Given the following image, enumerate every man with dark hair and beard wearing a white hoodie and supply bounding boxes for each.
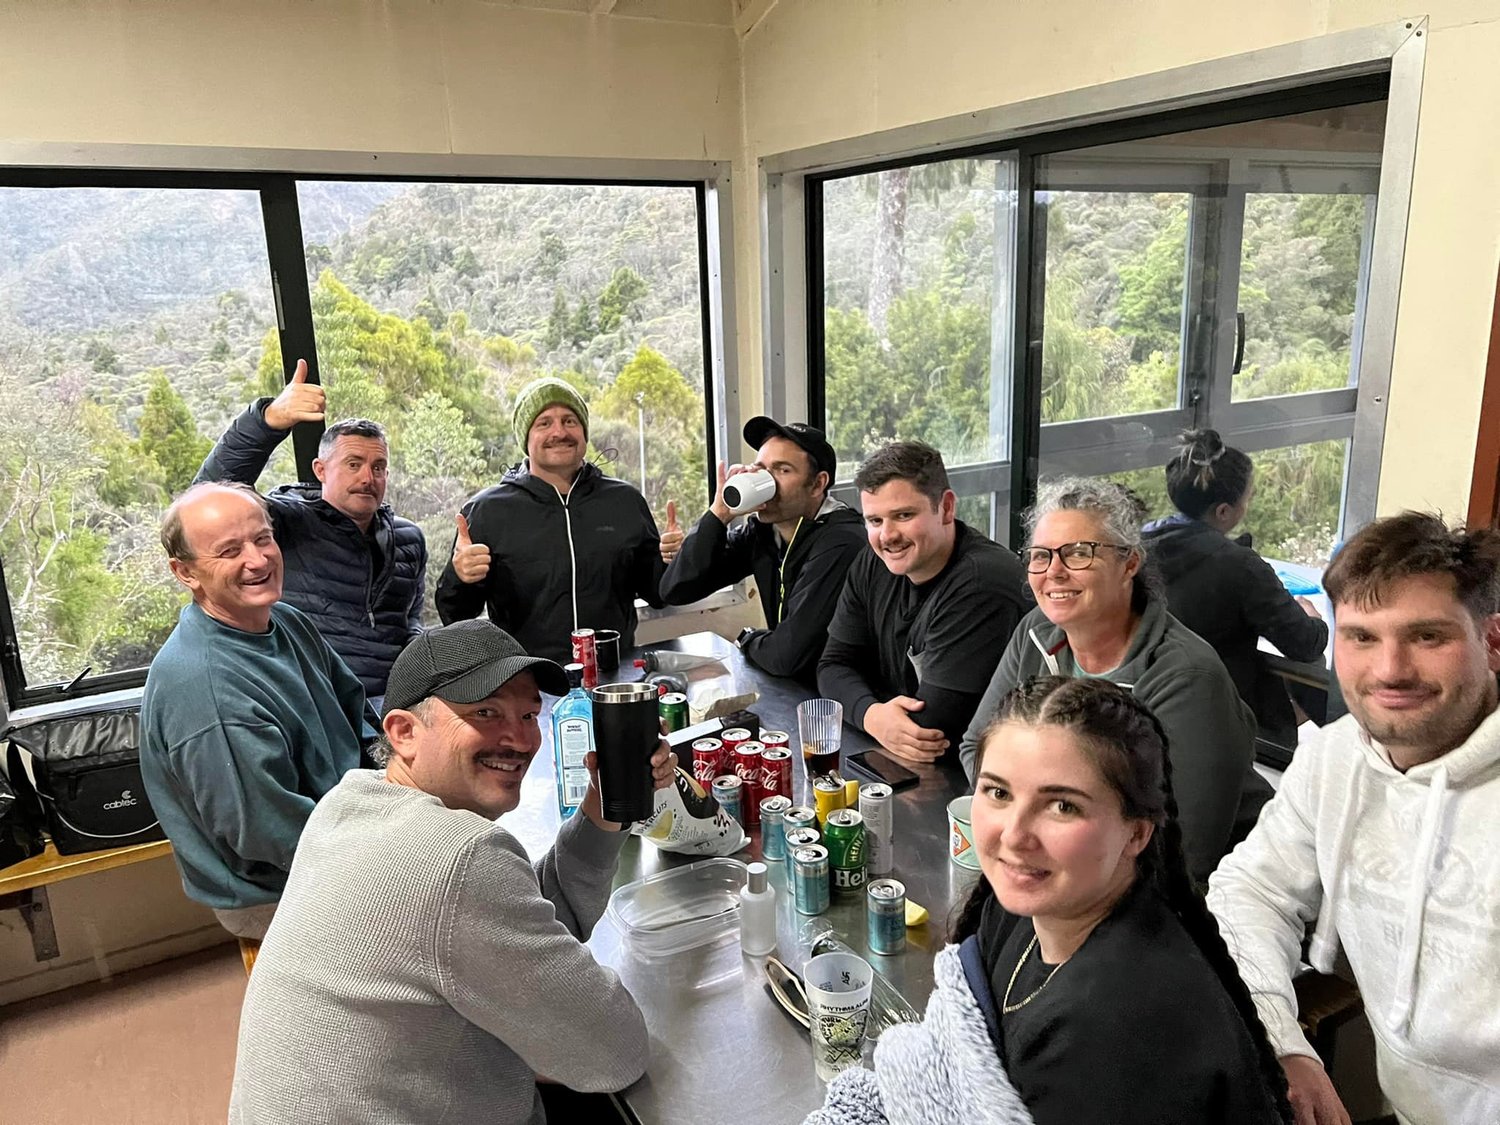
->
[1208,512,1500,1125]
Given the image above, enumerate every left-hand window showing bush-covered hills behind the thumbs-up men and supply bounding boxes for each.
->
[0,173,714,707]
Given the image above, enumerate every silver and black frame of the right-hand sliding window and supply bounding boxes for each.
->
[762,20,1427,552]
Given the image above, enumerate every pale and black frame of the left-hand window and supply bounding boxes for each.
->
[0,156,741,722]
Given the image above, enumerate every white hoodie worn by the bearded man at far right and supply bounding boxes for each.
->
[1208,711,1500,1125]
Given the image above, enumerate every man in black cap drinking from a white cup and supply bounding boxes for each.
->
[662,417,864,684]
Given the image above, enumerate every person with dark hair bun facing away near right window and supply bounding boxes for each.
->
[1143,429,1328,746]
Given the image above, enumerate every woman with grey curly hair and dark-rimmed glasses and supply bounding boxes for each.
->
[960,477,1271,884]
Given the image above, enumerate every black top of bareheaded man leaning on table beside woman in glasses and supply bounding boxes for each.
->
[819,521,1029,726]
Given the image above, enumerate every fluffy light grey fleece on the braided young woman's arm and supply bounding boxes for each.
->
[803,945,1032,1125]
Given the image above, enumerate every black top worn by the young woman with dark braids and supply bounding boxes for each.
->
[980,885,1281,1125]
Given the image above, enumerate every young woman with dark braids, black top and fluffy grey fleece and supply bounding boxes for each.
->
[807,677,1292,1125]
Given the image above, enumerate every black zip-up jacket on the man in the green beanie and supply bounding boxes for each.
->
[435,461,666,662]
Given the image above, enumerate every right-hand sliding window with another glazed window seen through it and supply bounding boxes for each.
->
[806,80,1386,564]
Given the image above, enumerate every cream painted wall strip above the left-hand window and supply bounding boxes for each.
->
[0,0,740,161]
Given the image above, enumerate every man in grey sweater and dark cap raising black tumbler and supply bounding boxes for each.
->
[230,621,672,1125]
